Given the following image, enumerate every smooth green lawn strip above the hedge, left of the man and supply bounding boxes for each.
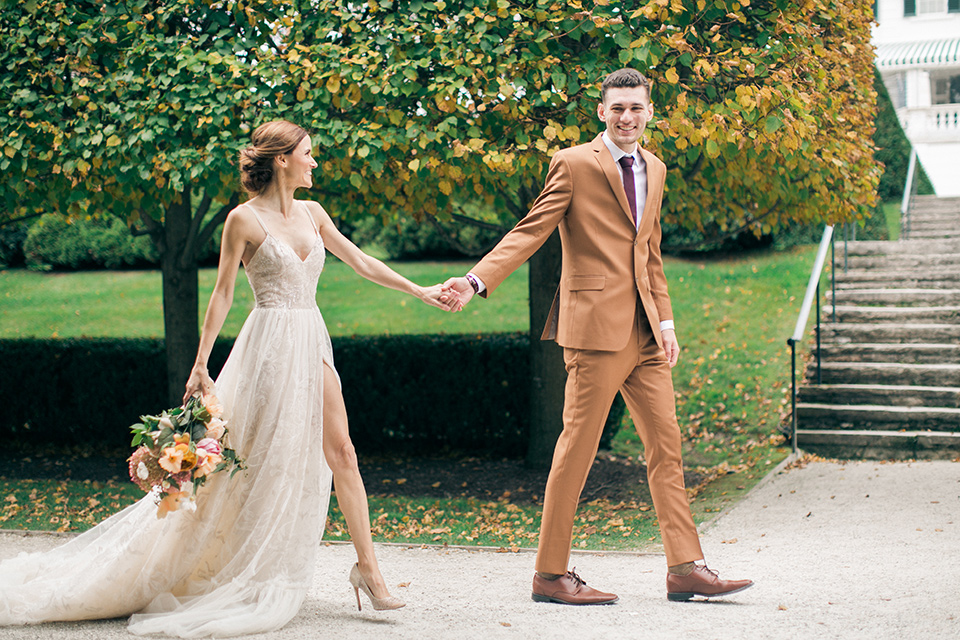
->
[0,260,530,338]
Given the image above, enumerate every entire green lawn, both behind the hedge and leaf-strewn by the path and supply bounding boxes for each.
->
[0,247,816,549]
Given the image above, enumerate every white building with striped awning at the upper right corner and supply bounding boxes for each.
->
[873,0,960,198]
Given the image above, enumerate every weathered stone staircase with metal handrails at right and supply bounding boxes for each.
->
[797,196,960,459]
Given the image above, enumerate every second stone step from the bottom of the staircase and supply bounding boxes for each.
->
[797,403,960,432]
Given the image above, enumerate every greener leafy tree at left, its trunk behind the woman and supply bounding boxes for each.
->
[0,0,286,400]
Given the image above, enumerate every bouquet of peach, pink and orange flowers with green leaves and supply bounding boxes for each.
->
[129,394,244,518]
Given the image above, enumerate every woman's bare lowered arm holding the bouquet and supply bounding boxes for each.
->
[183,209,247,402]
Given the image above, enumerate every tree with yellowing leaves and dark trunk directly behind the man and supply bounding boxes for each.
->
[276,0,879,464]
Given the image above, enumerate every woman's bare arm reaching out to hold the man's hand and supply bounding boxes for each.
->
[308,202,460,311]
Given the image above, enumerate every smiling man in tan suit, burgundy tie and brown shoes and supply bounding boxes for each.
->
[445,69,753,605]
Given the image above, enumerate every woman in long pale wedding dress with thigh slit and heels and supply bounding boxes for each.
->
[0,121,459,638]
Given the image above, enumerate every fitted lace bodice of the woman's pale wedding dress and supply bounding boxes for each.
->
[246,221,326,309]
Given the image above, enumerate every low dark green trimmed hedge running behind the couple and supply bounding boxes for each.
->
[0,333,624,458]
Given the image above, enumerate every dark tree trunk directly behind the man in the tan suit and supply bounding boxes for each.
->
[526,231,567,469]
